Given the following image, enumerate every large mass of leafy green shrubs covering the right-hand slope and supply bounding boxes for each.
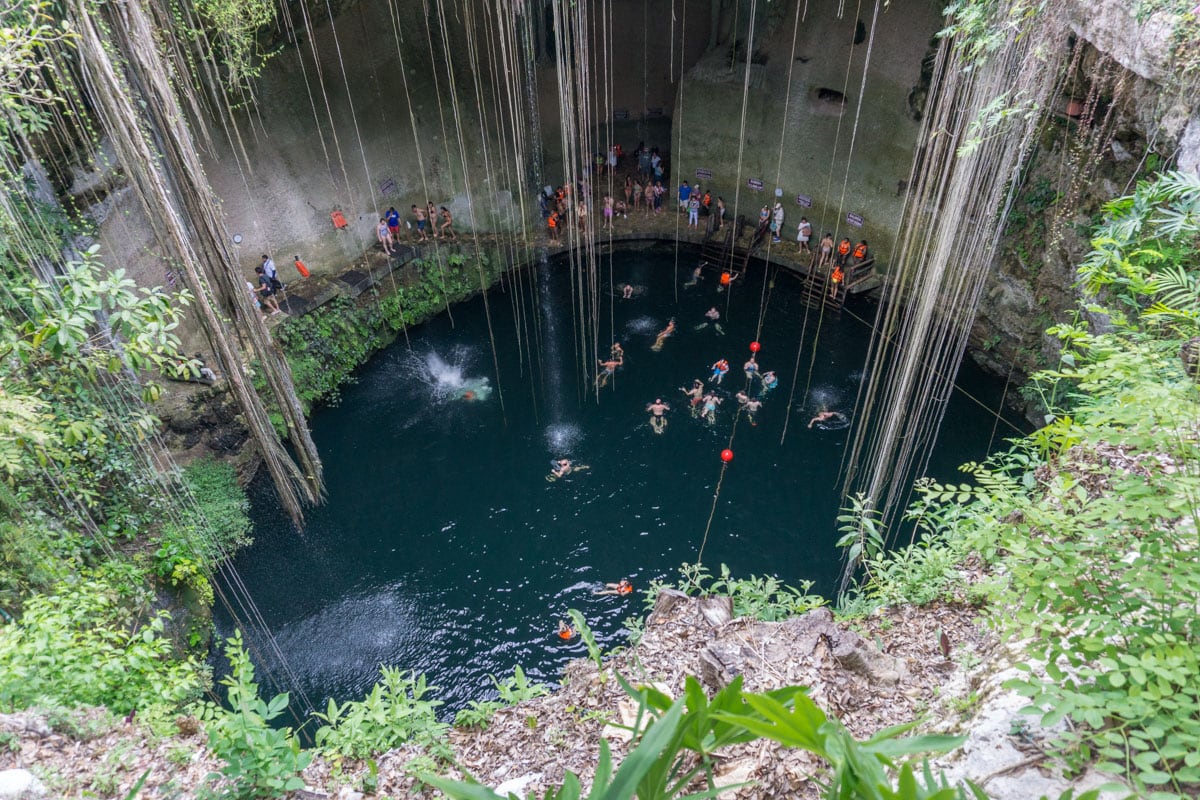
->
[840,174,1200,799]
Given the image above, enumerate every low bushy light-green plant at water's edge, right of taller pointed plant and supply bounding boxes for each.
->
[313,667,449,758]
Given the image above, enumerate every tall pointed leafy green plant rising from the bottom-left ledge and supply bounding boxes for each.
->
[203,631,312,799]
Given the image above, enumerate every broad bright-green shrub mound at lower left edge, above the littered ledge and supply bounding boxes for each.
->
[0,570,205,715]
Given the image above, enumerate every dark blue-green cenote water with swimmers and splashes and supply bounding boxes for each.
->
[218,251,1010,709]
